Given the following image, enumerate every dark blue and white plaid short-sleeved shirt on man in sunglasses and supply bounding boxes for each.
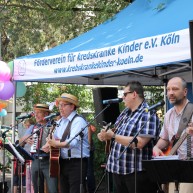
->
[106,101,159,175]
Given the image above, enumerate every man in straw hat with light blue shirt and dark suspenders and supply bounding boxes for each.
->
[44,93,89,193]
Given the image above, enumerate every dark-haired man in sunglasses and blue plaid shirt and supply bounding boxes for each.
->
[98,81,159,193]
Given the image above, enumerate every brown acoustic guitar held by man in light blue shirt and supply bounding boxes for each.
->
[50,126,60,177]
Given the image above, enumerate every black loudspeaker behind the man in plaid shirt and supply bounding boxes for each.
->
[93,87,120,125]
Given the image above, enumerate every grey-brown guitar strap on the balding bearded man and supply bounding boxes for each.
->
[175,103,193,139]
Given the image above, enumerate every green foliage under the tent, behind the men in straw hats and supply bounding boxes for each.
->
[17,82,94,113]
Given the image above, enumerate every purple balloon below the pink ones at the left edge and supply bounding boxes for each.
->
[0,81,15,100]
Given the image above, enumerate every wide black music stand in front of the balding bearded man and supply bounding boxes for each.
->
[142,160,193,192]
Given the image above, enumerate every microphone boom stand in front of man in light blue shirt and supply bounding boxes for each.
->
[67,104,110,193]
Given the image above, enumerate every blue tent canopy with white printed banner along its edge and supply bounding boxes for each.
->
[14,0,193,85]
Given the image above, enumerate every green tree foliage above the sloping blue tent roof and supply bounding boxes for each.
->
[0,0,129,61]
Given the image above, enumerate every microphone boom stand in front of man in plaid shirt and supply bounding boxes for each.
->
[117,110,156,193]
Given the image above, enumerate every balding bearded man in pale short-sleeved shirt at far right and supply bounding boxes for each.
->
[153,77,193,193]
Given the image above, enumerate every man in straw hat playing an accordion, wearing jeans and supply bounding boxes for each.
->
[26,104,58,193]
